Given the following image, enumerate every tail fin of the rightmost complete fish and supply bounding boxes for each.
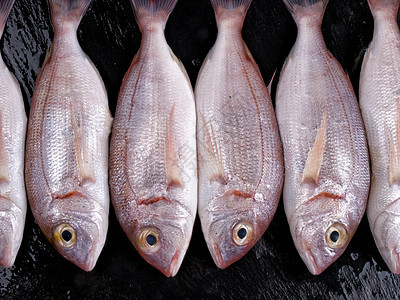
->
[283,0,329,25]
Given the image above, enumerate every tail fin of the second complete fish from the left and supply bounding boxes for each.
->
[131,0,178,31]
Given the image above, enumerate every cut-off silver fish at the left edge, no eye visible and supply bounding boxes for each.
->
[0,0,26,268]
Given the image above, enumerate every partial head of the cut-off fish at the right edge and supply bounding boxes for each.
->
[370,199,400,274]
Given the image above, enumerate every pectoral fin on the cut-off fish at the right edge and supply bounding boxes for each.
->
[389,100,400,186]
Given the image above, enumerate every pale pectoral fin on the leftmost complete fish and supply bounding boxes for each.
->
[71,103,95,185]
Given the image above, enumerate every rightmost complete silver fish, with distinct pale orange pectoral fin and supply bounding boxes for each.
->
[276,0,370,275]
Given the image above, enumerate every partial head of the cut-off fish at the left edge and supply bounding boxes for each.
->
[0,197,25,268]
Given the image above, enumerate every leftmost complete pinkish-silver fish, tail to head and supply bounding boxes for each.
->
[25,0,112,271]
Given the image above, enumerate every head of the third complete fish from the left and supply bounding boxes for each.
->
[200,191,270,269]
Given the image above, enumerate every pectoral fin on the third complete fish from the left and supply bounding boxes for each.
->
[200,113,226,184]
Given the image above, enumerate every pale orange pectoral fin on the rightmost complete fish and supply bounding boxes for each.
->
[301,107,328,184]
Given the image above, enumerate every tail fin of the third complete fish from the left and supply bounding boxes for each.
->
[211,0,252,27]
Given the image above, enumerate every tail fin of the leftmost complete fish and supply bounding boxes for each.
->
[49,0,91,27]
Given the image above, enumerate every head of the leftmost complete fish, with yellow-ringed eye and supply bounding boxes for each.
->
[40,191,108,271]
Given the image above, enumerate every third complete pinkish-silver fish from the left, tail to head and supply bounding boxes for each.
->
[195,0,283,268]
